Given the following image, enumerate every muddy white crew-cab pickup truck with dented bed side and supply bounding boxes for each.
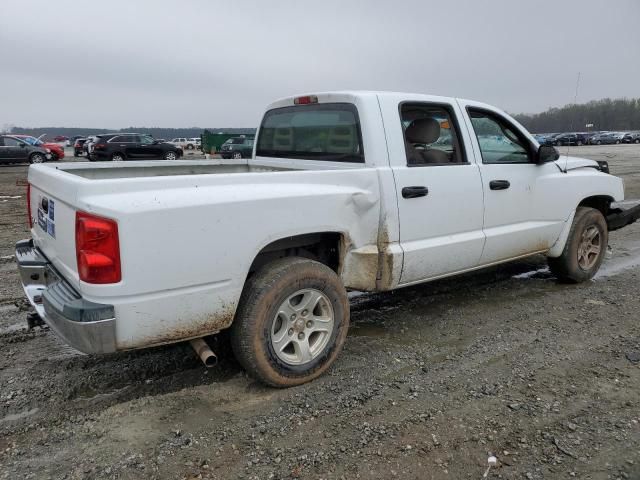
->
[16,92,640,386]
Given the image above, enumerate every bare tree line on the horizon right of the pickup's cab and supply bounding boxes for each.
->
[513,98,640,133]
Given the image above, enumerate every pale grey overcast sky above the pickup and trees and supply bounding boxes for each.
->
[0,0,640,129]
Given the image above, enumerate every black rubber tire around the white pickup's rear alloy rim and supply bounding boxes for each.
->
[231,257,349,388]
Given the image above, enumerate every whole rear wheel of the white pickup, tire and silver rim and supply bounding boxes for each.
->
[231,257,349,387]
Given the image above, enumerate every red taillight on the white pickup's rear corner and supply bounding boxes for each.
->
[76,212,122,283]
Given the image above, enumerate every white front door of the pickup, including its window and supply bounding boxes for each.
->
[467,106,567,264]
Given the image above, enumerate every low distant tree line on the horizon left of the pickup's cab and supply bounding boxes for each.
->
[8,126,255,140]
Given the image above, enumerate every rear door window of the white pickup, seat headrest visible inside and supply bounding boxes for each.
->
[400,103,466,166]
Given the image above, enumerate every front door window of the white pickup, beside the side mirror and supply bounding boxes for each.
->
[469,109,532,163]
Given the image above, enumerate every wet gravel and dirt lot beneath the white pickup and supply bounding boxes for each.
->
[0,146,640,479]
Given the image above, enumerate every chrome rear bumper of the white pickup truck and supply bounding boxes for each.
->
[16,240,116,353]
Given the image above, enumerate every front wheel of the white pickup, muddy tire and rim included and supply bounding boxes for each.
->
[548,207,609,283]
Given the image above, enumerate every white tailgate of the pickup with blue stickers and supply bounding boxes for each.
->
[29,167,78,285]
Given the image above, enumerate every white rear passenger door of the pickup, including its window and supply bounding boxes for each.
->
[380,95,484,285]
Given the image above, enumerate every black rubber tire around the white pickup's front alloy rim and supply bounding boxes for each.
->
[547,207,609,283]
